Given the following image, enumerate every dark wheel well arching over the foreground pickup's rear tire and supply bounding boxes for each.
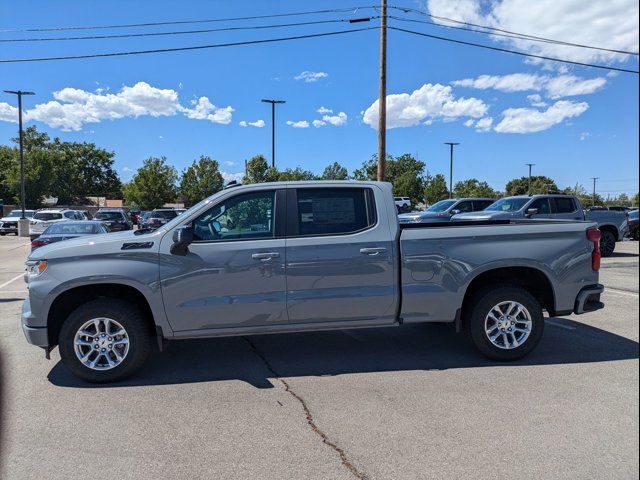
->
[462,267,555,324]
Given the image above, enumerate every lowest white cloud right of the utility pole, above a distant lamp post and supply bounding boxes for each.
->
[495,100,589,133]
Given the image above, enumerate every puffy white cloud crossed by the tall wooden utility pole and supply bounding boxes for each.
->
[363,83,489,128]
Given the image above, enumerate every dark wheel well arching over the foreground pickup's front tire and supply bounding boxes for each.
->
[47,283,155,346]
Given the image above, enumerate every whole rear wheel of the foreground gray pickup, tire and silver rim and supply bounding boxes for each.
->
[466,285,544,361]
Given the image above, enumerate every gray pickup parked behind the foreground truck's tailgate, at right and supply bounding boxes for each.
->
[452,194,628,257]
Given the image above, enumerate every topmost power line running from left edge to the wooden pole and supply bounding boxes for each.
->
[0,6,373,33]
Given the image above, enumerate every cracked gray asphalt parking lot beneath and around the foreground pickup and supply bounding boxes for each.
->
[0,236,639,479]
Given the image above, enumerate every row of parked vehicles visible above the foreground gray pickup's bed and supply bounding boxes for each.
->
[398,194,637,257]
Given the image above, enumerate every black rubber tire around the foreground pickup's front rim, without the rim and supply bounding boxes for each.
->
[58,298,151,383]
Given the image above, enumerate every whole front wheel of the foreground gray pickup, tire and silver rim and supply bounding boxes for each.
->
[58,298,151,383]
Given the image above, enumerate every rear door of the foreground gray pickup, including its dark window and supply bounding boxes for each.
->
[286,186,397,324]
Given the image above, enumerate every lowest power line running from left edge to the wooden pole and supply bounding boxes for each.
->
[0,27,378,63]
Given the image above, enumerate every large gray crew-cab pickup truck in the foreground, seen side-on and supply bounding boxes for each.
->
[22,181,603,382]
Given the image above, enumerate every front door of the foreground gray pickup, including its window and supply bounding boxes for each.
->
[160,189,287,331]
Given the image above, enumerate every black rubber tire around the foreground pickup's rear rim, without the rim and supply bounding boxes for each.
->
[465,284,544,361]
